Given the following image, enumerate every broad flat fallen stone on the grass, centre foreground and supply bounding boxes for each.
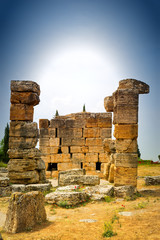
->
[45,191,88,206]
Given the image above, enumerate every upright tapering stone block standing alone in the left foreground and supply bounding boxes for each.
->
[4,192,46,233]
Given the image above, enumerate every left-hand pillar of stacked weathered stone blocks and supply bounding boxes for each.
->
[8,81,45,184]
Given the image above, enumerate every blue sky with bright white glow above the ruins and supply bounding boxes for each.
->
[0,0,160,161]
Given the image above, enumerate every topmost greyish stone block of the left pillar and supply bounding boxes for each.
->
[11,80,40,95]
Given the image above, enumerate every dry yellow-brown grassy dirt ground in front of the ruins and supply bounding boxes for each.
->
[0,165,160,240]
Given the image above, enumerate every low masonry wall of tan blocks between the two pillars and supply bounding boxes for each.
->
[39,112,112,177]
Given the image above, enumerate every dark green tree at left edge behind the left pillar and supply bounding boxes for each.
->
[0,123,9,163]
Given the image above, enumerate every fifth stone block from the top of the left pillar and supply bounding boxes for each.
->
[9,137,38,149]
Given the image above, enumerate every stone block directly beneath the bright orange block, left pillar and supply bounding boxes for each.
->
[9,121,38,138]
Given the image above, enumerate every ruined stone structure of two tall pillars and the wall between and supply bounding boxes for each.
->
[8,79,149,193]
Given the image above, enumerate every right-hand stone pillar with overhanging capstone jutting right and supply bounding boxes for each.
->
[104,79,149,187]
